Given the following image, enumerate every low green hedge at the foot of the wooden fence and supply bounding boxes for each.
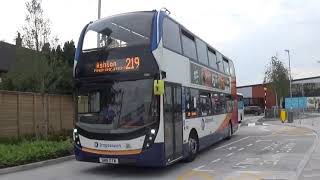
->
[0,135,73,168]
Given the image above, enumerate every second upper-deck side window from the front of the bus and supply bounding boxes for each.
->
[181,29,197,60]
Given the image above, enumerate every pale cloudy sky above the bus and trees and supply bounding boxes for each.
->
[0,0,320,86]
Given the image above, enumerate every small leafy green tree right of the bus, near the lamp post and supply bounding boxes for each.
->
[263,57,289,106]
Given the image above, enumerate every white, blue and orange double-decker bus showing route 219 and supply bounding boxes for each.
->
[73,10,238,166]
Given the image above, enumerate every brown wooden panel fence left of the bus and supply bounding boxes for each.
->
[0,91,74,137]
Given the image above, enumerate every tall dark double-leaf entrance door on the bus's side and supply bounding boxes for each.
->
[163,83,183,163]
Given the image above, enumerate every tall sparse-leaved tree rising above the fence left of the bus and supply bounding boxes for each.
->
[22,0,51,52]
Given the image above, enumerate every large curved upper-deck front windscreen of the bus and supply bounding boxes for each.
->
[82,12,154,50]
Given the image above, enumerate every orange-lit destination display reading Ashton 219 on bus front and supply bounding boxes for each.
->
[93,57,141,73]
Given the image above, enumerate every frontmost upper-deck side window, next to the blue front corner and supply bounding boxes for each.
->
[163,18,182,53]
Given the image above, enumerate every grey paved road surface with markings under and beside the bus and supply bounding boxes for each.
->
[0,116,320,180]
